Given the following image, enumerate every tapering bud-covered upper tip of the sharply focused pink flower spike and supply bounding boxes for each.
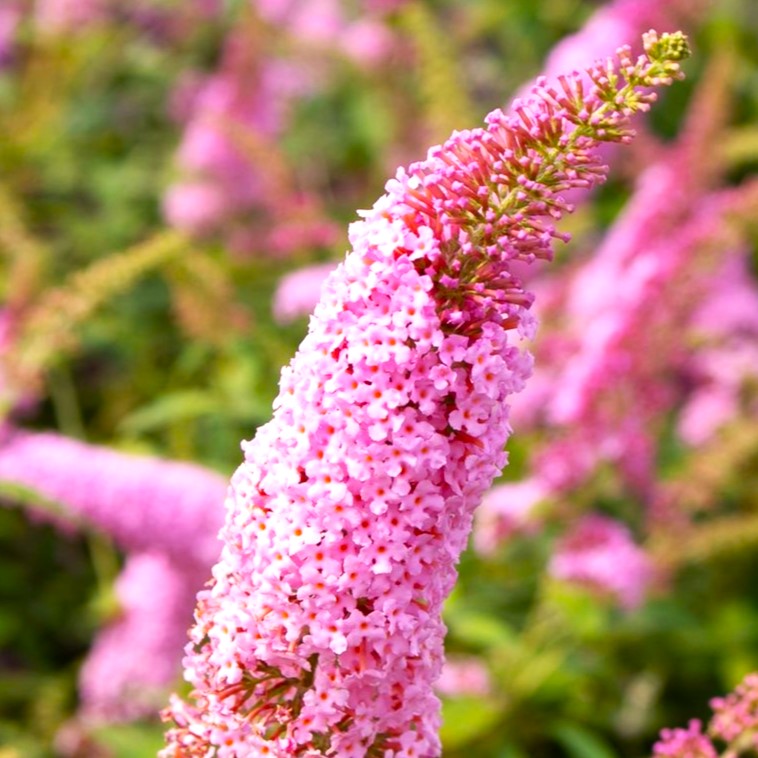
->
[388,34,686,336]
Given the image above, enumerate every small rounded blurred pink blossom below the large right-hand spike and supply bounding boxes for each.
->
[548,514,654,609]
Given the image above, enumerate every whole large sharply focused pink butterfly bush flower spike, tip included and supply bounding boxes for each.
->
[162,33,686,758]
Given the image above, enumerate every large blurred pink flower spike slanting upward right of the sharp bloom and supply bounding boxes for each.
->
[490,52,754,504]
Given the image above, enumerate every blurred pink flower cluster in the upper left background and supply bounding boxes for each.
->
[164,21,335,255]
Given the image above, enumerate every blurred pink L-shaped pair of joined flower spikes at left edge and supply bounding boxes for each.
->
[0,427,226,720]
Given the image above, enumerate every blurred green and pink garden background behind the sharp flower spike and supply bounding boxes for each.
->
[0,0,758,758]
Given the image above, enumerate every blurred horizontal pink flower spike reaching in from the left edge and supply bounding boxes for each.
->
[0,430,227,569]
